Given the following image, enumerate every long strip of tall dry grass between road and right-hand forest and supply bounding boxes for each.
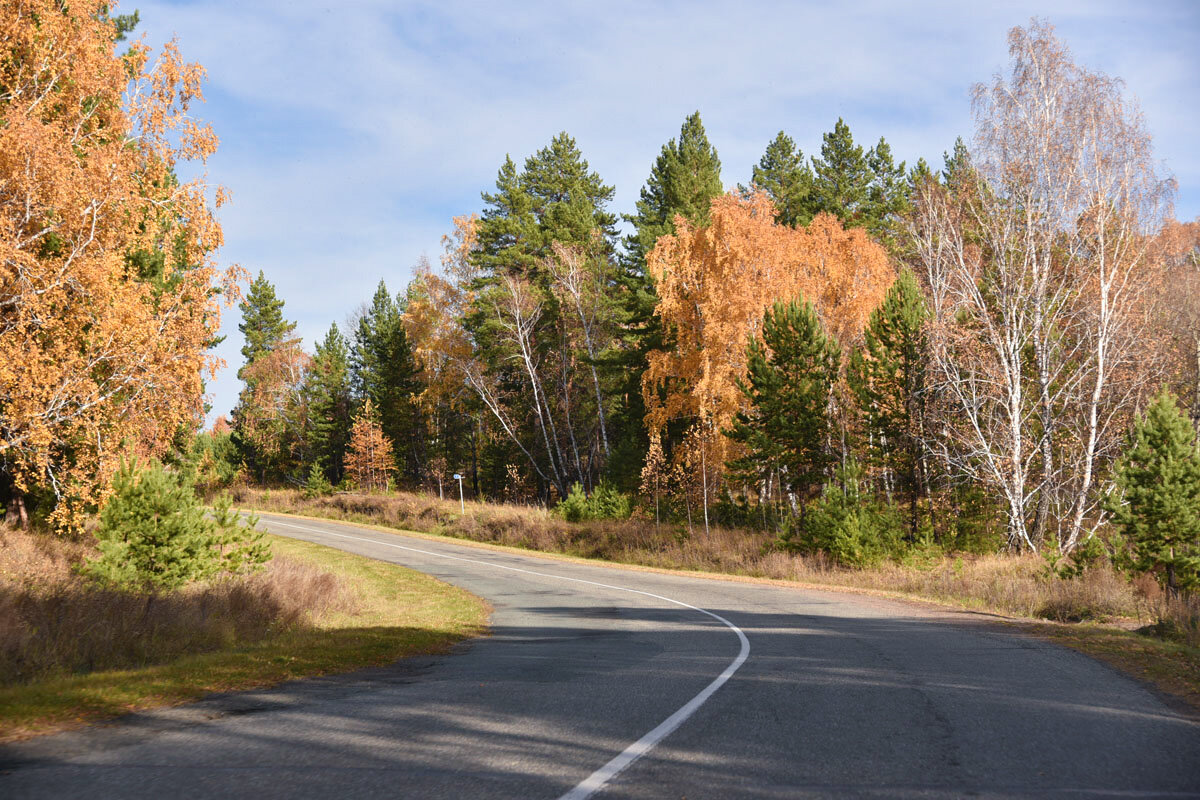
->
[235,488,1154,621]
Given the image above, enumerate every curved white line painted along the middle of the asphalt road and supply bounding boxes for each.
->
[260,519,750,800]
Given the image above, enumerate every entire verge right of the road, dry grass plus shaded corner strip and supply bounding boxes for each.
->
[238,489,1200,712]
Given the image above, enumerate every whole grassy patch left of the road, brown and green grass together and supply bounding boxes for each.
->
[0,525,488,741]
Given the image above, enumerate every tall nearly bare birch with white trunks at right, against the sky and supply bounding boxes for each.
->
[911,20,1172,551]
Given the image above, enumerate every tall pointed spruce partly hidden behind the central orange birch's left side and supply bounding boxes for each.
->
[610,112,724,491]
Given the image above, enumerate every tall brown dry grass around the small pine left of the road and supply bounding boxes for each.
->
[0,529,355,686]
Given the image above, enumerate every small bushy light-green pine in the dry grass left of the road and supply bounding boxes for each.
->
[82,462,270,593]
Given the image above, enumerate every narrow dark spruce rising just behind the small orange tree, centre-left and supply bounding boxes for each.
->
[349,281,422,482]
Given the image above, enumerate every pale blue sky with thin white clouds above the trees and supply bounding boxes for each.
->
[120,0,1200,424]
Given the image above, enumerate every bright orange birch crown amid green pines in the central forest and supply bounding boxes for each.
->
[642,192,895,484]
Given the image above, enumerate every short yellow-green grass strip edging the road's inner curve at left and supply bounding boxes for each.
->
[0,536,490,742]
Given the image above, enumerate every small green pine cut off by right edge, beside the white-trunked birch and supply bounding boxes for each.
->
[1106,391,1200,595]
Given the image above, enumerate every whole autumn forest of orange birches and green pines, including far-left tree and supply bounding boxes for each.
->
[0,2,1200,593]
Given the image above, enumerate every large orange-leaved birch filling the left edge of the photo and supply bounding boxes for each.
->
[0,0,240,530]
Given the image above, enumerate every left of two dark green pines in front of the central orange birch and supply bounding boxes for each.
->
[728,301,840,513]
